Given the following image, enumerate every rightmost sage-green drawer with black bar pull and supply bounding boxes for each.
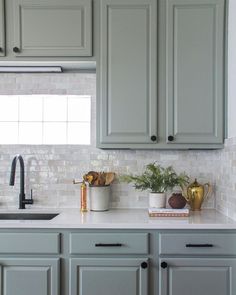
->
[160,233,236,255]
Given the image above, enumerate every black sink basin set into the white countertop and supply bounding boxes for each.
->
[0,213,58,220]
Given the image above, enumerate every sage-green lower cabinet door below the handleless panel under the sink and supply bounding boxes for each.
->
[0,258,59,295]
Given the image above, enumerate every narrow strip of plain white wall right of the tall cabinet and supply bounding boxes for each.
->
[228,0,236,138]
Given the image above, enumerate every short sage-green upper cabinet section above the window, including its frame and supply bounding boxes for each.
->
[0,0,95,62]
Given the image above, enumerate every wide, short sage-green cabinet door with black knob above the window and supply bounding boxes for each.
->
[12,0,92,57]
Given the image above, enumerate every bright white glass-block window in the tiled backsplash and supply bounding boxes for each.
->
[0,94,91,145]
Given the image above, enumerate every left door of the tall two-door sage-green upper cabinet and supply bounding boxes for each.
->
[97,0,157,146]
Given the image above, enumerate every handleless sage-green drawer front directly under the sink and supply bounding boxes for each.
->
[0,233,60,254]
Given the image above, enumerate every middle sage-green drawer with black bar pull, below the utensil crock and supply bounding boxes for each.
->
[70,233,148,254]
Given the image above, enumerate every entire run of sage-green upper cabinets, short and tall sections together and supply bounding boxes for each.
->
[0,0,228,149]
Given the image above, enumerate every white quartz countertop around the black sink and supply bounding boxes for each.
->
[0,209,236,230]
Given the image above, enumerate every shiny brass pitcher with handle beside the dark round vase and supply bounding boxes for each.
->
[183,179,212,211]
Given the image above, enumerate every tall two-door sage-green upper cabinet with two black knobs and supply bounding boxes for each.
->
[97,0,226,149]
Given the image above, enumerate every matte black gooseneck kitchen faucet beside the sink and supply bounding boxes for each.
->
[9,155,33,209]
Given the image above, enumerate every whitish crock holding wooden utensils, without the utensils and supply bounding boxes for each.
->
[89,185,110,211]
